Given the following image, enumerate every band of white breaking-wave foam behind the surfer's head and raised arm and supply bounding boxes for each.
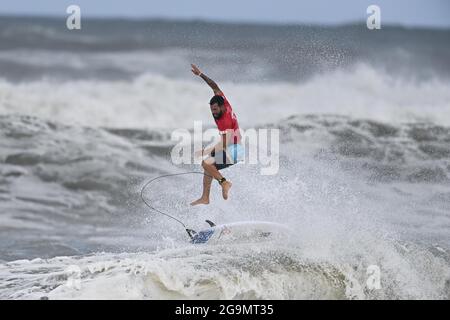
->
[0,64,450,128]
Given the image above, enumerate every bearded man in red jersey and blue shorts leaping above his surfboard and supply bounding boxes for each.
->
[191,64,243,206]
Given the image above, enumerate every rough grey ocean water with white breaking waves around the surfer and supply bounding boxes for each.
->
[0,17,450,299]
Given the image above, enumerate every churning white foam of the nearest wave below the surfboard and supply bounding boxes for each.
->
[0,230,449,299]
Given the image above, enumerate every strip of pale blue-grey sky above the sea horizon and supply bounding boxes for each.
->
[0,0,450,28]
